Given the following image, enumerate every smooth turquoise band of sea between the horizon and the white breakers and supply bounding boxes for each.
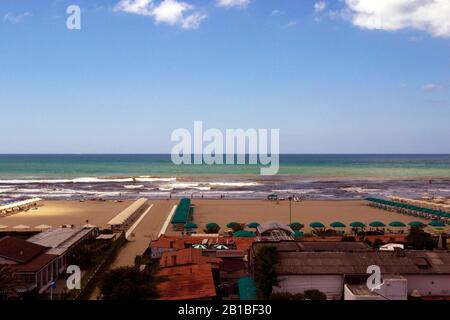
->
[0,155,450,179]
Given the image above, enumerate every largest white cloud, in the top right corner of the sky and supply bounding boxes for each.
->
[345,0,450,37]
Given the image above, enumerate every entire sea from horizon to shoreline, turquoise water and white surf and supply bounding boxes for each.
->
[0,154,450,202]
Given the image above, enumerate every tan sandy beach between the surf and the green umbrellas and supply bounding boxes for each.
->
[0,199,426,236]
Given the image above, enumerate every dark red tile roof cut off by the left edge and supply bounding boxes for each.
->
[0,236,49,263]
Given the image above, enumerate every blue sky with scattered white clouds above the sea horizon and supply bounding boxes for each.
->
[0,0,450,153]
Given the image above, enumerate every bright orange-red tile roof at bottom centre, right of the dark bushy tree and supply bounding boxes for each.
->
[158,264,216,300]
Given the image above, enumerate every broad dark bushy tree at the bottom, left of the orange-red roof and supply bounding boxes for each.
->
[100,267,160,300]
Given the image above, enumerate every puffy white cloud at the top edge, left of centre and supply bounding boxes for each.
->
[114,0,206,29]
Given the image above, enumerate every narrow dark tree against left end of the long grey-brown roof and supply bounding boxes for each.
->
[255,246,279,300]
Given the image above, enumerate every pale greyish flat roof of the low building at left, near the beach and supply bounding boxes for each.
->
[27,227,94,255]
